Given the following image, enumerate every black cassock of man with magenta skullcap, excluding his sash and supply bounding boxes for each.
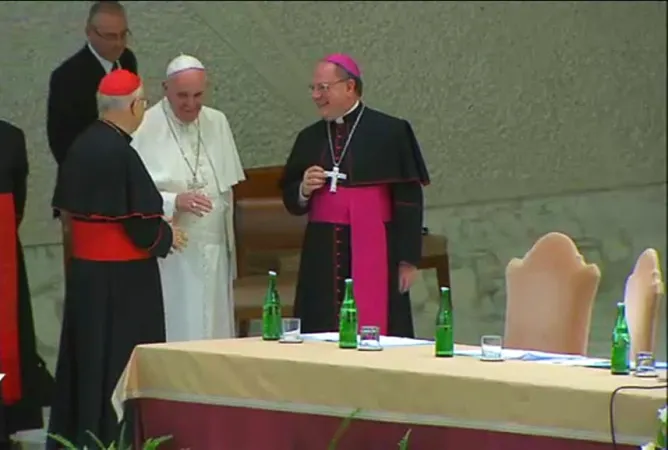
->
[281,104,429,337]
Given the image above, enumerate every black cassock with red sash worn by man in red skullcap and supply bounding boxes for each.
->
[47,121,172,449]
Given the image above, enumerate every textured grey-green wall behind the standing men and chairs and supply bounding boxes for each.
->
[0,1,666,366]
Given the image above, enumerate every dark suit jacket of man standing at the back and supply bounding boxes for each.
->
[46,45,137,216]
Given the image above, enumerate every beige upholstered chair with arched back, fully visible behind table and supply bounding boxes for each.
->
[503,233,601,354]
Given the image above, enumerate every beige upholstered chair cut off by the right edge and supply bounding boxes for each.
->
[624,248,664,360]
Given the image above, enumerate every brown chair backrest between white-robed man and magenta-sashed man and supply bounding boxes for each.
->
[234,166,306,278]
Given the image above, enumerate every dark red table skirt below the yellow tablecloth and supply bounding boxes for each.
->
[132,399,638,450]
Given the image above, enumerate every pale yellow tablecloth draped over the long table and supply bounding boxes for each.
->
[114,338,666,444]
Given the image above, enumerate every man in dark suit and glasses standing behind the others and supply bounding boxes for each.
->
[46,1,137,263]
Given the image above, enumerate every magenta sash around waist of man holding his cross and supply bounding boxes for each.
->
[309,186,392,335]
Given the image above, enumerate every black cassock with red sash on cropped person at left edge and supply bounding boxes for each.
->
[0,121,53,448]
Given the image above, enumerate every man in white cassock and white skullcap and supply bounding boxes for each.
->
[132,55,244,341]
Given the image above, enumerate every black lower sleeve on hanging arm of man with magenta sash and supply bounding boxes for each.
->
[391,181,424,266]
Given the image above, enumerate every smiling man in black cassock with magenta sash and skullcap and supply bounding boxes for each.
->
[282,53,429,337]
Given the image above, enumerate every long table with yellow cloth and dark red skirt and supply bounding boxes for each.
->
[114,338,665,450]
